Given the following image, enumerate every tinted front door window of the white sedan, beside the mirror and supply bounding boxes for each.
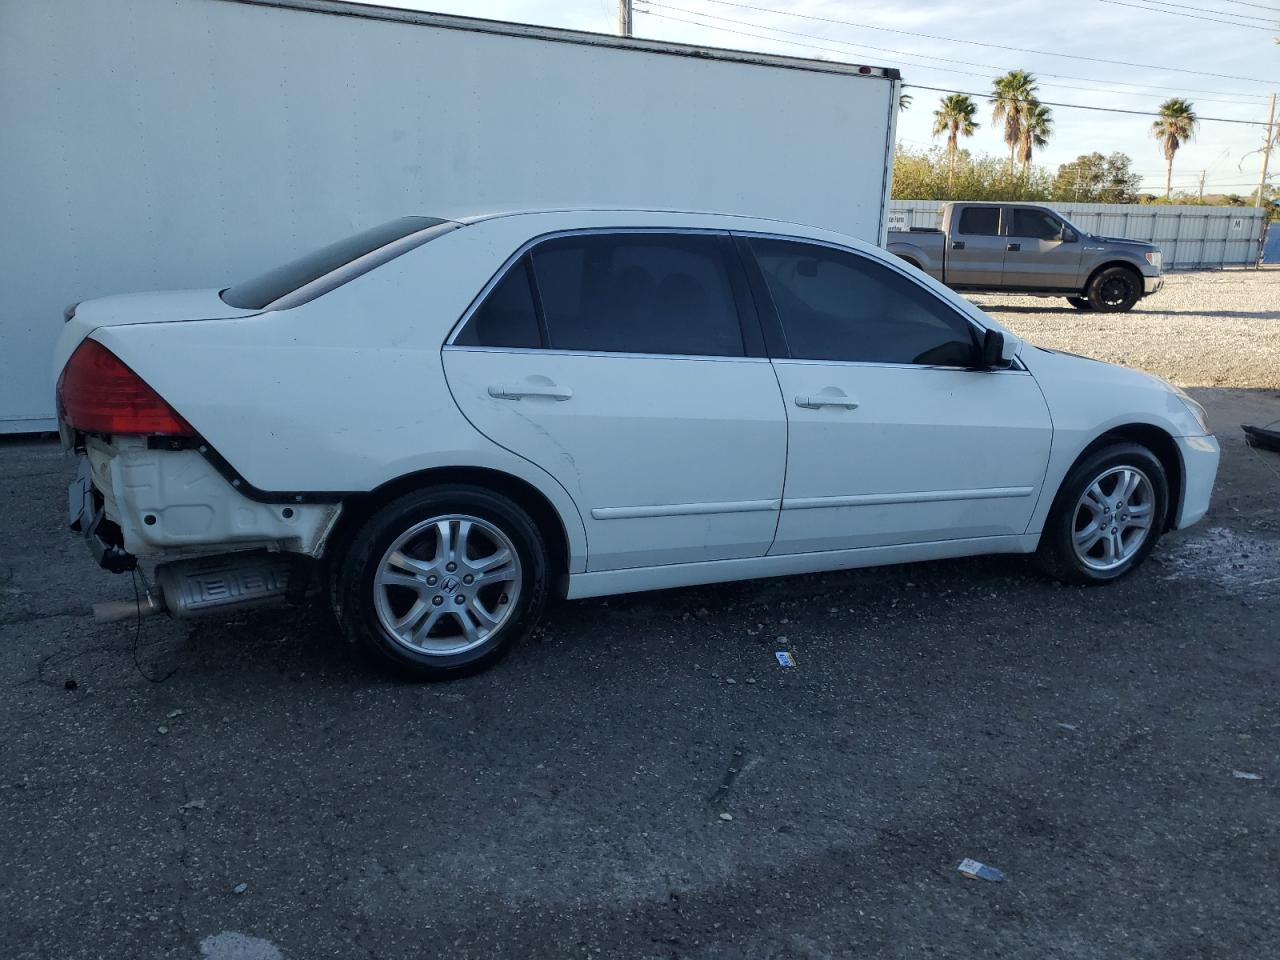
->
[751,239,977,366]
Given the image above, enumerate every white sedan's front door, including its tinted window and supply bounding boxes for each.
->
[742,237,1052,554]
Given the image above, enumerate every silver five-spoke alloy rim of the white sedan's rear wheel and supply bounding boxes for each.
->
[374,515,522,655]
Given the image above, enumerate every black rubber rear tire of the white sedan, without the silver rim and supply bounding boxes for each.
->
[332,484,549,680]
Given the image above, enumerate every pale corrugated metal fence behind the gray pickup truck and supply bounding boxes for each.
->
[888,200,1267,270]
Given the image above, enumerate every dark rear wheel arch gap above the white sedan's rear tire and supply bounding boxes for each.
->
[325,466,572,579]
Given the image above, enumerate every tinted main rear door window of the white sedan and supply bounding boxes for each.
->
[534,233,744,357]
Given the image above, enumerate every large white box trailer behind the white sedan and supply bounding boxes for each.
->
[0,0,900,433]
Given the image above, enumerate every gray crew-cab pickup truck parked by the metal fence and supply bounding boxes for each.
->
[888,204,1165,312]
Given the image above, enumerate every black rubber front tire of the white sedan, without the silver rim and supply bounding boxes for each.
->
[1036,443,1169,584]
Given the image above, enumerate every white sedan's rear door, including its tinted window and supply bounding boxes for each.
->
[444,230,787,571]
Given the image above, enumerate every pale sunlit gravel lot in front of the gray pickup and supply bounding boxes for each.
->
[974,269,1280,389]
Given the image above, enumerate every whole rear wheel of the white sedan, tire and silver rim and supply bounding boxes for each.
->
[335,485,548,680]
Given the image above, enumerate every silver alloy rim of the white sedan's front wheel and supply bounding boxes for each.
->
[1071,466,1156,572]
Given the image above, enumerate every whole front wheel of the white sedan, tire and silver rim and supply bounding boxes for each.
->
[1036,443,1169,584]
